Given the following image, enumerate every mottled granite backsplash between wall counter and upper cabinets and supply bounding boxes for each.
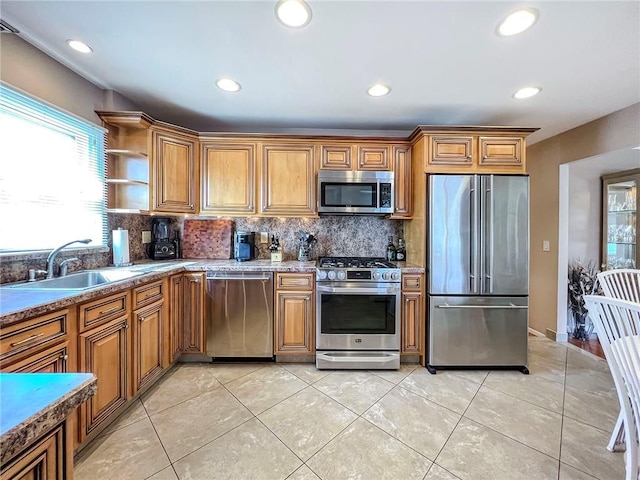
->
[0,213,404,283]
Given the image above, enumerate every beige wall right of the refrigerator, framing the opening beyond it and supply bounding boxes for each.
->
[527,103,640,333]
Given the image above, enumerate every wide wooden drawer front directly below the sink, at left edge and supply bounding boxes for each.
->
[0,310,69,361]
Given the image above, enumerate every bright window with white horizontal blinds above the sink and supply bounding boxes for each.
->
[0,84,107,252]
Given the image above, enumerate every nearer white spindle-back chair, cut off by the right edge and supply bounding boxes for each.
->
[584,295,640,480]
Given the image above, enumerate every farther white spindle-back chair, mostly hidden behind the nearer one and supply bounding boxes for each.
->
[598,268,640,452]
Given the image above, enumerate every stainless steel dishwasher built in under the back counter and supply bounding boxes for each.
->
[206,272,273,360]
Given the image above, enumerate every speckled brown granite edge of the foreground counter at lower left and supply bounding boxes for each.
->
[0,373,98,465]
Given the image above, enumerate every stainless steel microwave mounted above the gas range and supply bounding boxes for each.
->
[318,170,394,215]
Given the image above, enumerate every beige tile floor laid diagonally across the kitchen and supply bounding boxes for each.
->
[76,337,624,480]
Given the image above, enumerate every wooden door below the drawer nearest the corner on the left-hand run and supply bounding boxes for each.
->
[132,300,165,395]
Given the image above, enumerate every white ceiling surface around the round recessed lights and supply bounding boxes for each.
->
[0,0,640,144]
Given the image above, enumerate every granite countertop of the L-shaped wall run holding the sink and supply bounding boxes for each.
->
[0,259,424,327]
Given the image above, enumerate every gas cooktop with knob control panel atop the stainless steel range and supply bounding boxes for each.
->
[316,257,400,283]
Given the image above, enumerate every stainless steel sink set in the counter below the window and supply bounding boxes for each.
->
[4,270,147,290]
